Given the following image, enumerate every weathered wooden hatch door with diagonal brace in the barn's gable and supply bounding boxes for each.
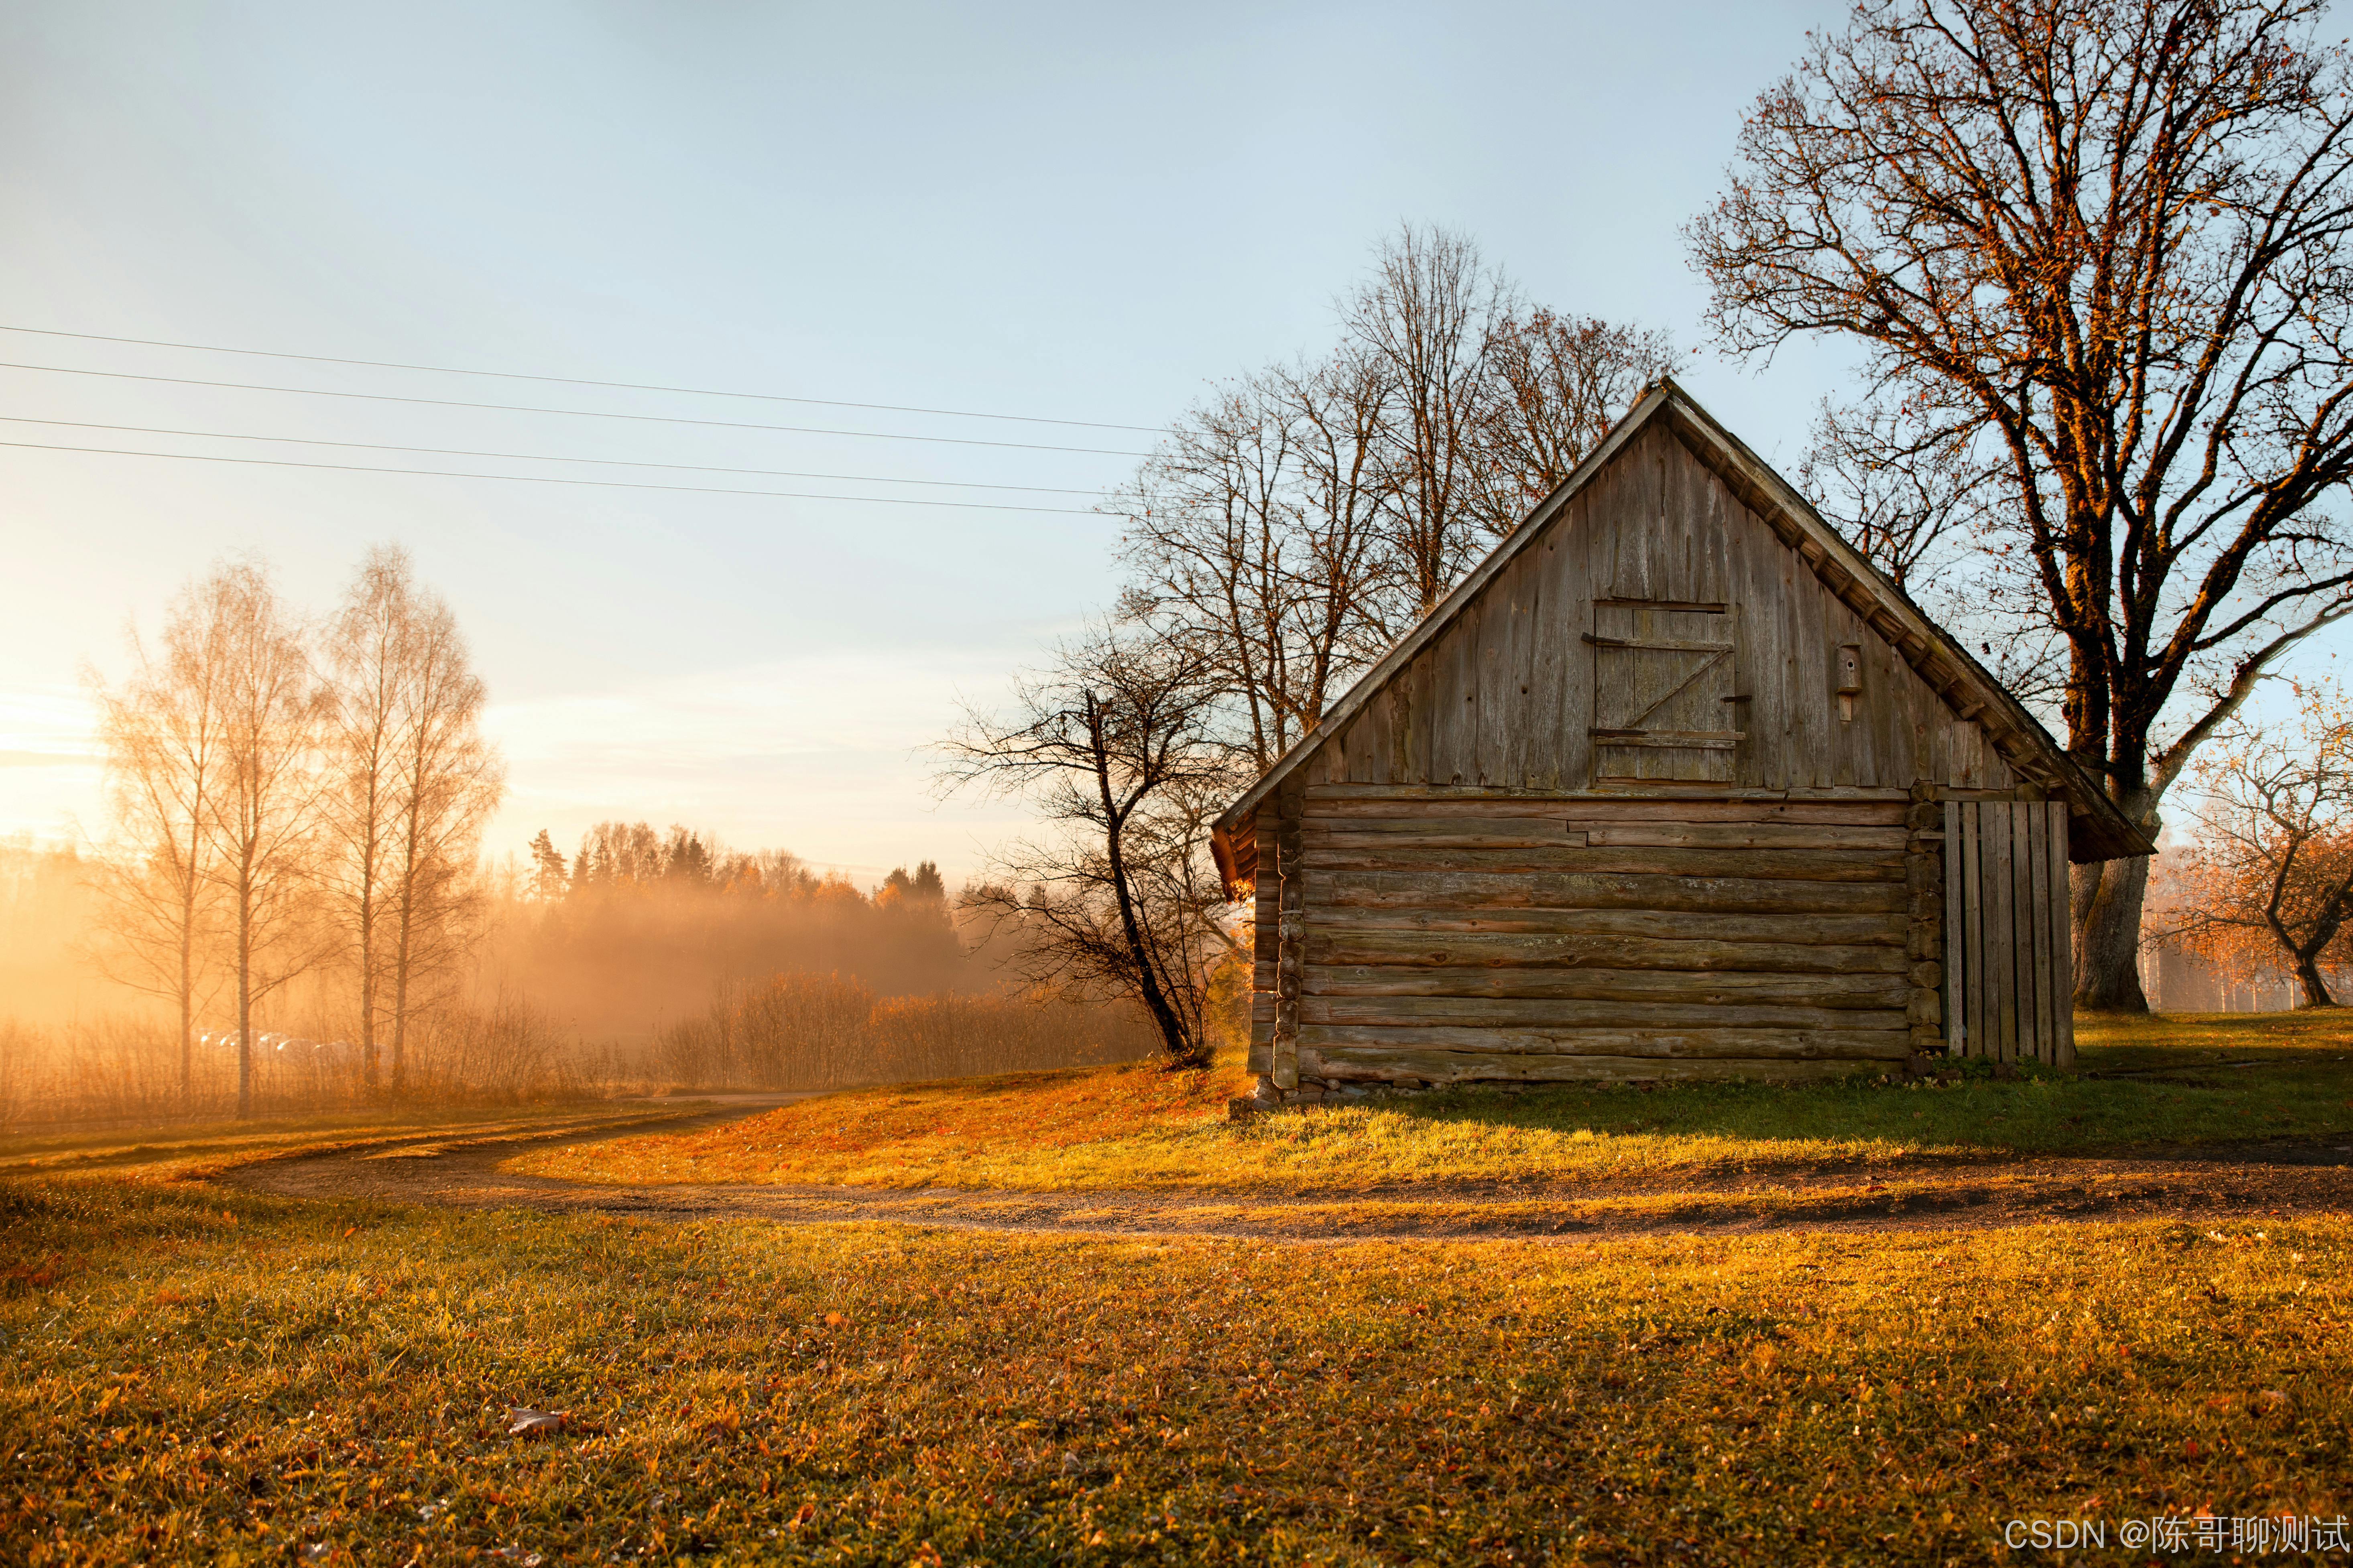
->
[1586,599,1741,783]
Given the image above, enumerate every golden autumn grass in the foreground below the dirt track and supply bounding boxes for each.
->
[0,1178,2353,1566]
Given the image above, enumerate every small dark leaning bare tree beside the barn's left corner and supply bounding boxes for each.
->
[941,628,1238,1067]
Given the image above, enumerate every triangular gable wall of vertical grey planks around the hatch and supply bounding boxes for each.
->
[1308,423,2017,792]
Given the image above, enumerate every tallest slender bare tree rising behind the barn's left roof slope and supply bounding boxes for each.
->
[1341,223,1518,616]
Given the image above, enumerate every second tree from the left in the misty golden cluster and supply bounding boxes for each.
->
[197,562,325,1117]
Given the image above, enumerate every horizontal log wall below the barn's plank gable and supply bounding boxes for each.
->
[1299,785,1915,1081]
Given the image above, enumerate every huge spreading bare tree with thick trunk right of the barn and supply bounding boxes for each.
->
[1690,0,2353,1011]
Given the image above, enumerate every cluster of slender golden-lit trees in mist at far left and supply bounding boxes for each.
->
[99,545,504,1117]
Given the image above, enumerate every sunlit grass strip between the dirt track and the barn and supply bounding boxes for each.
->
[518,1013,2353,1192]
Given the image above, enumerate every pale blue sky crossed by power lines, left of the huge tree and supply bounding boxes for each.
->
[0,0,1882,877]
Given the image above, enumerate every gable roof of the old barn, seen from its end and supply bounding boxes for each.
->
[1210,376,2156,879]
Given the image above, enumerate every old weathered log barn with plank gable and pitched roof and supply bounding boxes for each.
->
[1212,381,2151,1100]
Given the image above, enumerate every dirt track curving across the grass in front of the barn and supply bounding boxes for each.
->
[226,1095,2353,1241]
